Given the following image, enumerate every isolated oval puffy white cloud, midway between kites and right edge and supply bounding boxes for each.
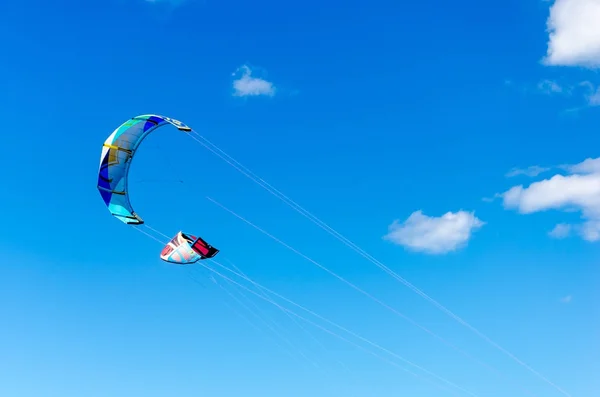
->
[384,210,485,254]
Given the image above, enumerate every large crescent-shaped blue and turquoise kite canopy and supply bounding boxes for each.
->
[97,114,192,225]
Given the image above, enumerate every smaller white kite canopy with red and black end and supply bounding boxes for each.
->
[160,232,219,265]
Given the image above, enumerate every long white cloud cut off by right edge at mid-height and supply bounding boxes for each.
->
[502,158,600,241]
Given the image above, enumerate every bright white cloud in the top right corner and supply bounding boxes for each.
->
[544,0,600,67]
